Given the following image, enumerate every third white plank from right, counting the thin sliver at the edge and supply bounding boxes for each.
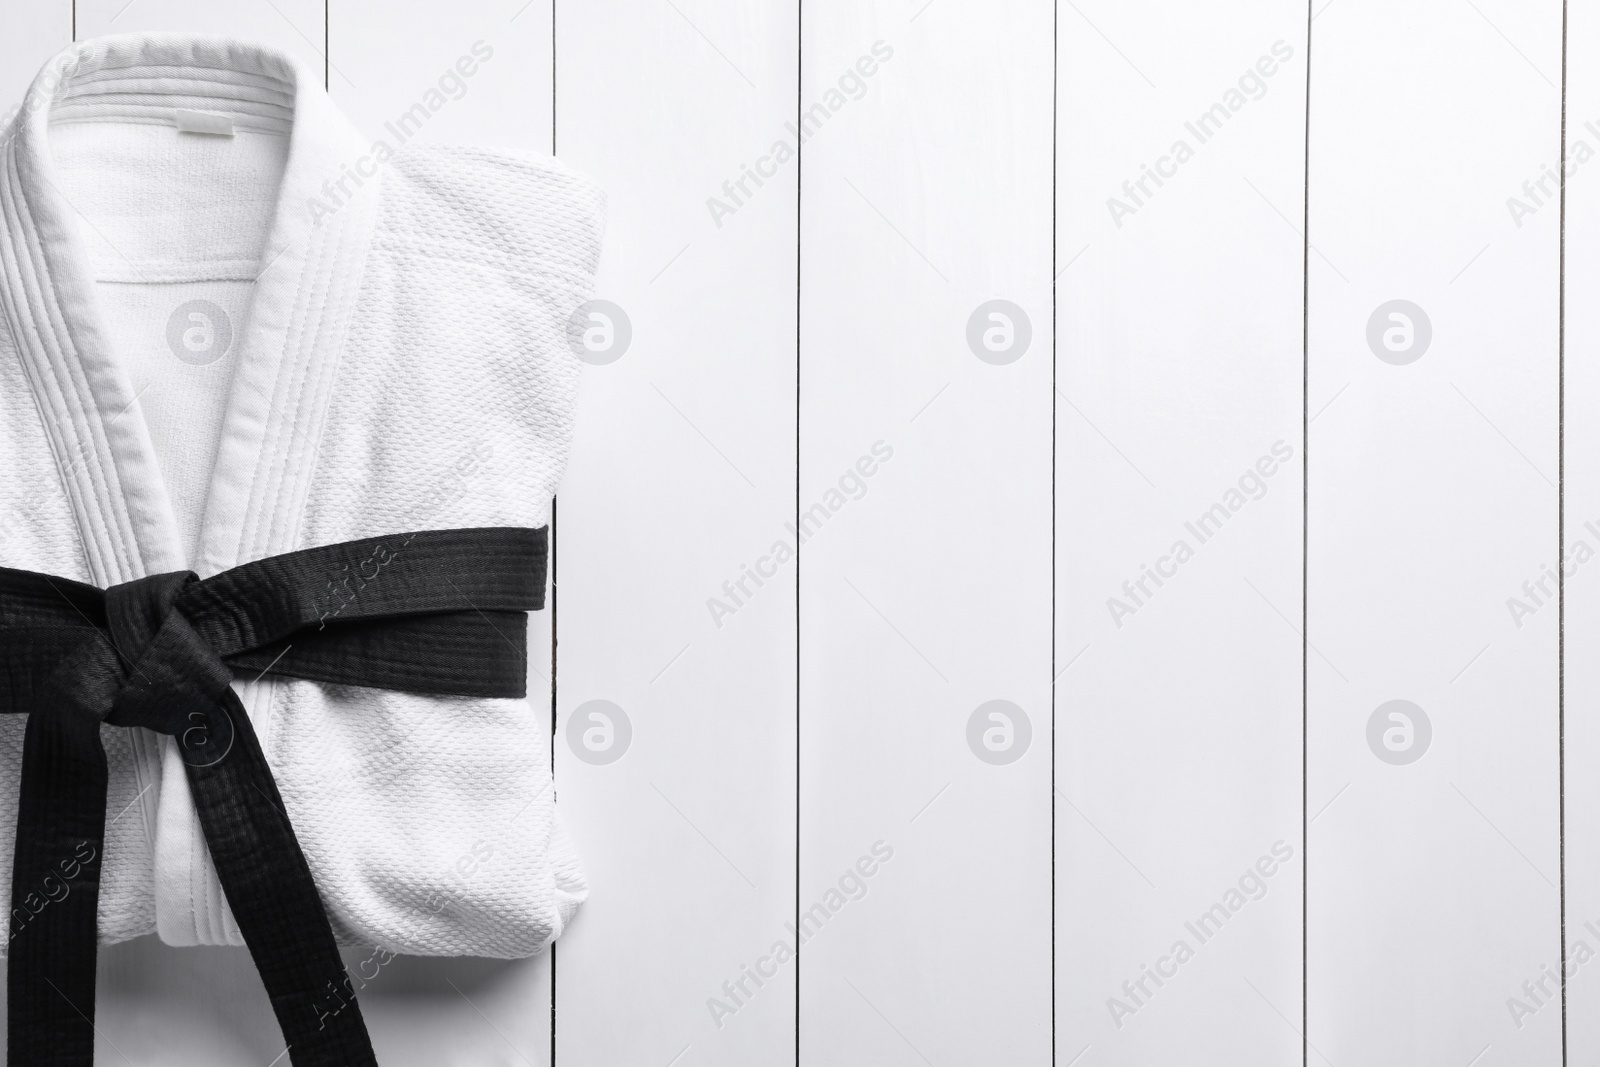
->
[1056,0,1307,1065]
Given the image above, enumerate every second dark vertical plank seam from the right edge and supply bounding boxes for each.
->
[1301,0,1312,1067]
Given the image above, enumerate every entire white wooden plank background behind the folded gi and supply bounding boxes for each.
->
[0,0,1580,1067]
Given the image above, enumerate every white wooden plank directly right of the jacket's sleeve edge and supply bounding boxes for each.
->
[555,0,798,1067]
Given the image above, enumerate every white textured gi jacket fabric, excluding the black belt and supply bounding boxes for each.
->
[0,35,602,957]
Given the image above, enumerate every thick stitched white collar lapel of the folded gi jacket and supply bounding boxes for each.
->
[0,34,378,585]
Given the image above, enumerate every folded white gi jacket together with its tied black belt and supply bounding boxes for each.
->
[0,35,602,1064]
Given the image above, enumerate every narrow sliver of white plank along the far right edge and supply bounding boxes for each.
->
[1561,0,1600,1064]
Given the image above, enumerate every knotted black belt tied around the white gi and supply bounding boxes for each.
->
[0,528,547,1067]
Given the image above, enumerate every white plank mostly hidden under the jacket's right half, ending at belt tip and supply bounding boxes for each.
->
[326,0,555,1067]
